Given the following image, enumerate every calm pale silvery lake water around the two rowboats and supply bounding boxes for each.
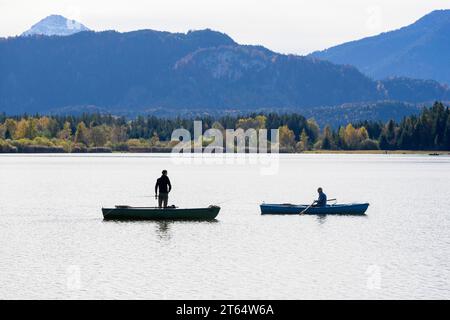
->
[0,154,450,299]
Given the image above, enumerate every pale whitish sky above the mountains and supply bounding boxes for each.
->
[0,0,450,54]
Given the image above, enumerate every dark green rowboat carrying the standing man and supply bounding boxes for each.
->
[102,206,220,220]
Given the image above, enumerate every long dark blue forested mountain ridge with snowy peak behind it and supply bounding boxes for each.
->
[0,11,450,119]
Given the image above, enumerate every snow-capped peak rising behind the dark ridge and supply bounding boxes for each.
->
[22,15,89,36]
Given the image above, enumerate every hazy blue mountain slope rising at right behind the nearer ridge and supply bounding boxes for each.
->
[311,10,450,84]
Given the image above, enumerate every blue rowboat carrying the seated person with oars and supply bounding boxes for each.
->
[260,203,369,215]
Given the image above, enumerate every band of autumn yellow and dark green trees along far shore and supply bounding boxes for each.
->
[0,102,450,152]
